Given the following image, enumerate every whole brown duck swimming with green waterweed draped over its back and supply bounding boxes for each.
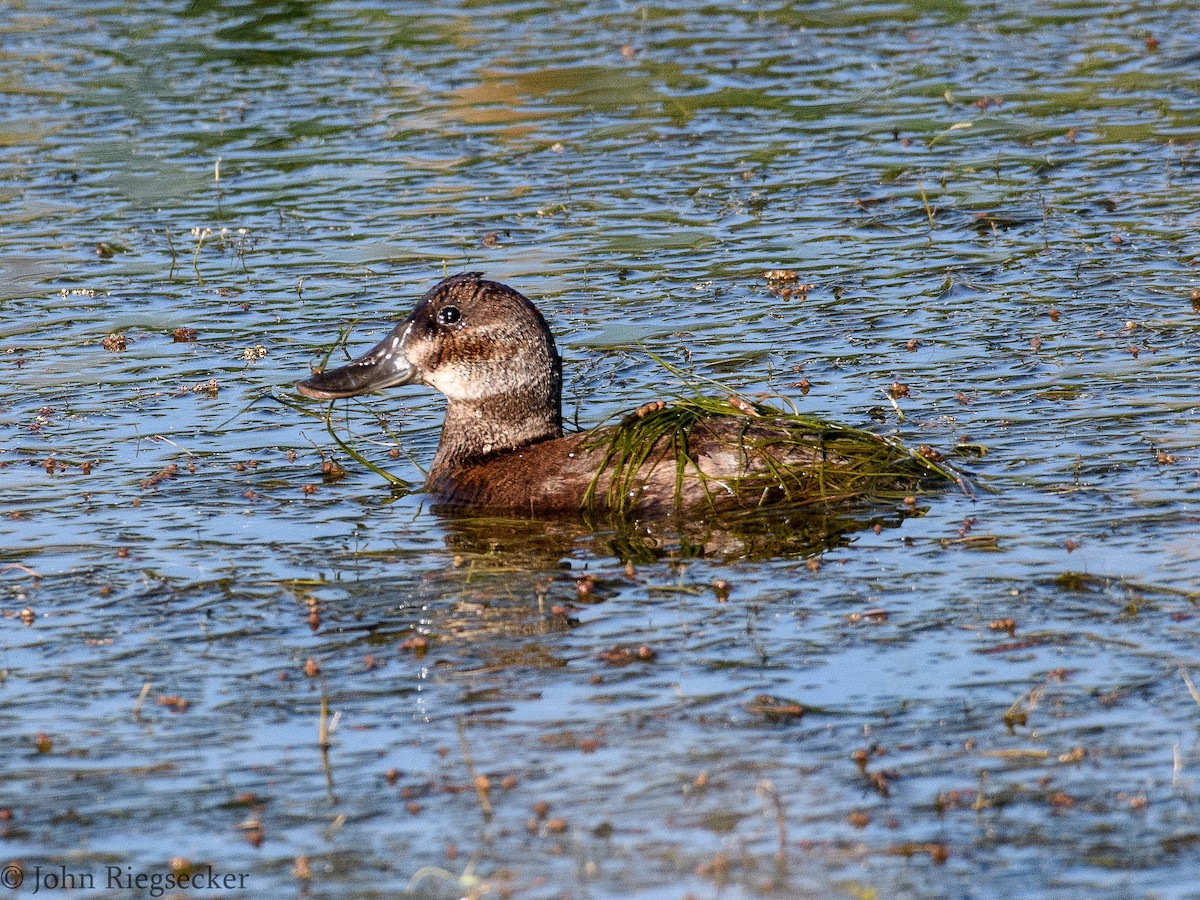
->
[296,272,958,517]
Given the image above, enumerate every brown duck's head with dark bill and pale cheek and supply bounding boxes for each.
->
[296,272,563,460]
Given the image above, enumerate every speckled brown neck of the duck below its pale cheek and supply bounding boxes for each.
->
[428,396,563,482]
